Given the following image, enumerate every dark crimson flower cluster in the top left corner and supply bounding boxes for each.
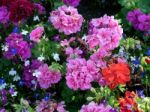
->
[9,0,33,22]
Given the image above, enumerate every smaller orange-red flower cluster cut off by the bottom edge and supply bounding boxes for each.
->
[119,91,142,112]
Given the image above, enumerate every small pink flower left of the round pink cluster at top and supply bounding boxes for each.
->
[30,26,44,43]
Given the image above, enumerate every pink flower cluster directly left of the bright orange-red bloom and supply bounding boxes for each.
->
[66,58,98,90]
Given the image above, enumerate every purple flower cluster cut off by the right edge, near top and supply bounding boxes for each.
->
[127,9,150,31]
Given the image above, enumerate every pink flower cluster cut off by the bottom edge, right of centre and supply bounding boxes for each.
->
[80,102,117,112]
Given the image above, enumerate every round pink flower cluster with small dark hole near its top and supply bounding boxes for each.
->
[49,5,83,35]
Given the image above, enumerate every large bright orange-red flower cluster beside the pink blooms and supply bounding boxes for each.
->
[102,62,130,89]
